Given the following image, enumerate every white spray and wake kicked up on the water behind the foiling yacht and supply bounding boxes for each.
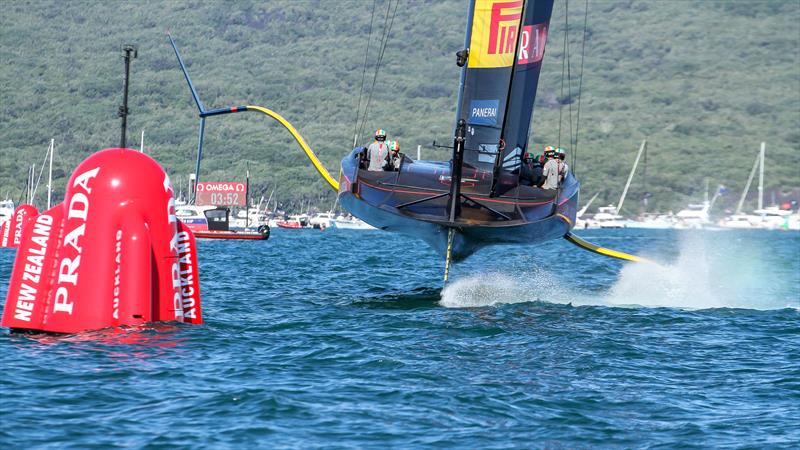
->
[439,233,800,310]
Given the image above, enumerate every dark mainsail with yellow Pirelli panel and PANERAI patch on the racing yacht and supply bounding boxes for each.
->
[456,0,553,194]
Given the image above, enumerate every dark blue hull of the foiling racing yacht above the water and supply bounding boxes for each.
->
[339,148,579,261]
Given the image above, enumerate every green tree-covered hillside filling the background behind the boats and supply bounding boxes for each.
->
[0,0,800,213]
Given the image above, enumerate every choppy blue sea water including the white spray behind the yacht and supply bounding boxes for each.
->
[0,229,800,448]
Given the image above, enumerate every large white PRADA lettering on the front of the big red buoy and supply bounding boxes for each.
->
[53,167,100,315]
